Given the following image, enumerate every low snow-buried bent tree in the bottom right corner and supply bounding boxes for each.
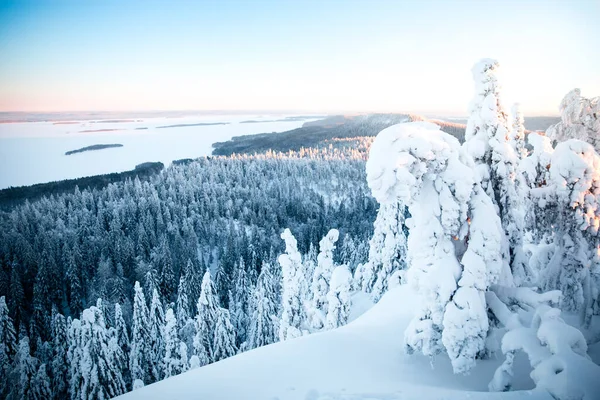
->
[486,288,600,400]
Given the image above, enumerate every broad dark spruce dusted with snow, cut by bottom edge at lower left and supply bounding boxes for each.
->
[78,306,126,399]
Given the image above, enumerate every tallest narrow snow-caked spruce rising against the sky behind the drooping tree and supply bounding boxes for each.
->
[463,59,531,284]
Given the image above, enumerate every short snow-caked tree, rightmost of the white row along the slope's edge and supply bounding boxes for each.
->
[325,265,352,329]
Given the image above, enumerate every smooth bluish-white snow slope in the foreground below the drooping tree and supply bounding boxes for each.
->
[121,285,564,400]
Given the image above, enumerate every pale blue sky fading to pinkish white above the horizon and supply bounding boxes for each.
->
[0,0,600,115]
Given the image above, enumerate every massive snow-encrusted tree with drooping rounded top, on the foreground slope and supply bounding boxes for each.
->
[371,123,510,372]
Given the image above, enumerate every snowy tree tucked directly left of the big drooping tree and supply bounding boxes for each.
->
[355,202,406,301]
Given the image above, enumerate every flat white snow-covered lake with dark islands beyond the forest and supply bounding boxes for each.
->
[0,115,316,189]
